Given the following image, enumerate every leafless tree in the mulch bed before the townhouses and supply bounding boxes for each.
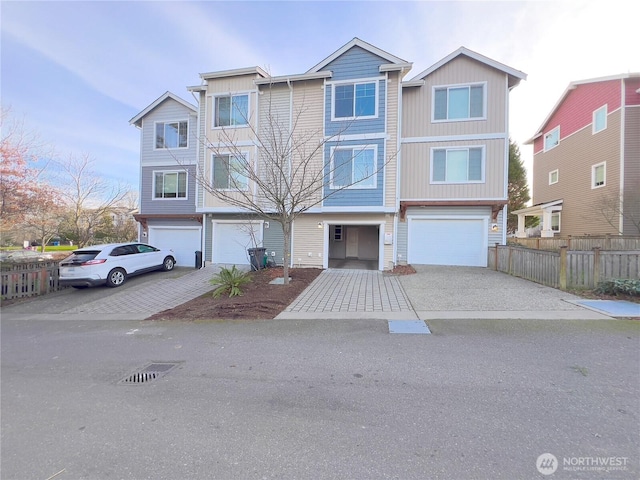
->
[197,85,389,284]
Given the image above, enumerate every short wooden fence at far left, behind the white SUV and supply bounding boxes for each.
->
[0,262,60,300]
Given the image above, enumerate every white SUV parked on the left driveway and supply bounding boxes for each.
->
[60,242,176,288]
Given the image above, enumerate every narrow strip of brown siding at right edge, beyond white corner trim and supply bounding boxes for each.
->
[623,106,640,235]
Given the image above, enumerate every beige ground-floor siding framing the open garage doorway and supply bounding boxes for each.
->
[292,214,395,270]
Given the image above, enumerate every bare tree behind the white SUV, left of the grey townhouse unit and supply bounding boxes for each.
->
[59,154,130,247]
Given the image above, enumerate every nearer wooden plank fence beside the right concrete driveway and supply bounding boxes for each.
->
[488,245,640,290]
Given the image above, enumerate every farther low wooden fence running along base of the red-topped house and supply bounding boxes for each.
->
[508,235,640,251]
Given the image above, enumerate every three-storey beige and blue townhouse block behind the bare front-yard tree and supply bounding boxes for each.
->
[132,38,526,270]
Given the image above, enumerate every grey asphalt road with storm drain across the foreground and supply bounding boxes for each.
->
[1,318,640,480]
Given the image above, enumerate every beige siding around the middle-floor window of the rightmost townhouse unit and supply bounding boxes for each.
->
[400,140,505,200]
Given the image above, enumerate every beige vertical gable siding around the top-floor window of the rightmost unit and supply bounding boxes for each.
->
[402,56,508,138]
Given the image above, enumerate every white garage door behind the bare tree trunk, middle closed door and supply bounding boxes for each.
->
[212,222,262,265]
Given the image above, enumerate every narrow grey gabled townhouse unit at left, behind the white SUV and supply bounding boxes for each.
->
[129,92,202,266]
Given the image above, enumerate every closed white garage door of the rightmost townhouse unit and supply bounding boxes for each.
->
[407,218,488,267]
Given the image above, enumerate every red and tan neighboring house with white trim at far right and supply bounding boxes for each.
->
[513,73,640,237]
